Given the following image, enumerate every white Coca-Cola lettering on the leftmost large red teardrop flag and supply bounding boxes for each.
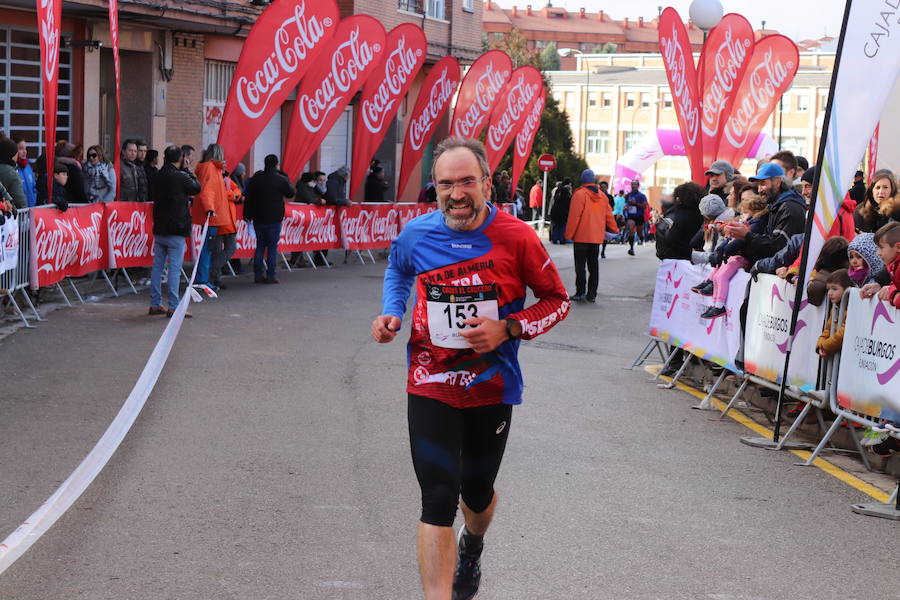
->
[236,1,333,119]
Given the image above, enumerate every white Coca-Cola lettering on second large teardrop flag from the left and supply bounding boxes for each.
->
[297,27,381,133]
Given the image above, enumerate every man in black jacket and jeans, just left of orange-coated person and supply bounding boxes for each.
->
[148,146,200,317]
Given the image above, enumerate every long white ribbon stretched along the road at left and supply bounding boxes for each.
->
[0,217,209,573]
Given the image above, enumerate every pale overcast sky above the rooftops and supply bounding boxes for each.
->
[495,0,852,40]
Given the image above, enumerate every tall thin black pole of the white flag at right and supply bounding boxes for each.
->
[773,0,853,442]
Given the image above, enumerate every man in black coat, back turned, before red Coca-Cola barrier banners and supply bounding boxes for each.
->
[244,154,294,283]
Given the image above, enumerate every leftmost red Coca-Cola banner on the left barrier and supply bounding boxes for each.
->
[30,204,109,289]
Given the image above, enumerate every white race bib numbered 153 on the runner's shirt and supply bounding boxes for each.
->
[425,283,499,349]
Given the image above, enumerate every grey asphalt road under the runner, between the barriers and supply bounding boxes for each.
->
[0,240,900,600]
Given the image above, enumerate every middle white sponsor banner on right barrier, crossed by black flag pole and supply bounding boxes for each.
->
[744,275,828,391]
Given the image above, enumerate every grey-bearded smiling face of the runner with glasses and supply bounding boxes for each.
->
[434,148,491,231]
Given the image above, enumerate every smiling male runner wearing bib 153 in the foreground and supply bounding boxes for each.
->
[372,137,569,600]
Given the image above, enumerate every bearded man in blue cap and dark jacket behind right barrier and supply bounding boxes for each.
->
[725,162,806,265]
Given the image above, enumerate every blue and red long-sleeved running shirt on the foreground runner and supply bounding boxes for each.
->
[382,204,569,408]
